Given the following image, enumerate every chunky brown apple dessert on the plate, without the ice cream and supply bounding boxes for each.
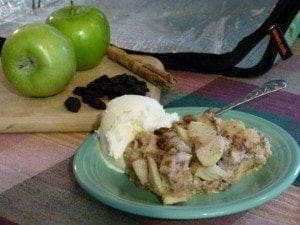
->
[124,110,272,204]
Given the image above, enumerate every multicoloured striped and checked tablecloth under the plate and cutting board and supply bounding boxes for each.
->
[0,41,300,225]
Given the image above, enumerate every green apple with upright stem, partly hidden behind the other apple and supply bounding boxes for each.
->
[46,5,110,70]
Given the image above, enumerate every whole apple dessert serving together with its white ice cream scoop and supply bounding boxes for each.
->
[98,95,272,204]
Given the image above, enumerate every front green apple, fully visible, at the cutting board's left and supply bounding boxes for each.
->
[1,23,76,97]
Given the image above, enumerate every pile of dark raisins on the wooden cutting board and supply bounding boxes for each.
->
[65,73,149,112]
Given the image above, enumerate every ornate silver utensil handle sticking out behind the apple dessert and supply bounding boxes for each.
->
[215,80,286,116]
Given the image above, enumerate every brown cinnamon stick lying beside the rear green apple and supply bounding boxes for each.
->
[107,45,177,88]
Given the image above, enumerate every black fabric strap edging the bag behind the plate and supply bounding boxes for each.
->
[129,0,300,77]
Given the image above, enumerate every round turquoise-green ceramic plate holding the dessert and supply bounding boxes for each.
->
[73,107,300,219]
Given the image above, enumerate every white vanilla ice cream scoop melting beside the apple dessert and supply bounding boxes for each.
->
[98,95,179,172]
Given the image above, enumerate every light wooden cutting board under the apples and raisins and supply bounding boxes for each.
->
[0,56,163,133]
